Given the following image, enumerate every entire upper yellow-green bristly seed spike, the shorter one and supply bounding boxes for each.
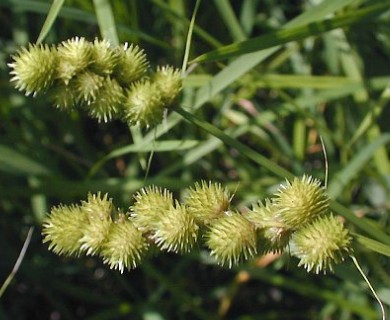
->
[8,37,182,127]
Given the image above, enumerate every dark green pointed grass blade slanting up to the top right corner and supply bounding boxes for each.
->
[190,3,390,63]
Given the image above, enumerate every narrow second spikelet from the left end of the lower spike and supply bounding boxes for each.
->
[80,192,114,255]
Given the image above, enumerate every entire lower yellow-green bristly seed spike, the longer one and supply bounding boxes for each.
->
[43,176,352,273]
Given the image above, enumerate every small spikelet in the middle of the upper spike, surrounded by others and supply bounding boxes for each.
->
[74,71,104,105]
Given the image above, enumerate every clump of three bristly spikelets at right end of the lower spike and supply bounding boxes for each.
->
[246,175,352,273]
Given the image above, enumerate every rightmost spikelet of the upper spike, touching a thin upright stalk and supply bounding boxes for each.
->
[152,66,182,107]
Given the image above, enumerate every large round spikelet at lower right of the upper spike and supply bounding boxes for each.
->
[123,80,164,128]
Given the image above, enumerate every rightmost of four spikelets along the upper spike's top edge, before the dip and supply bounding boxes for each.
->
[114,42,148,86]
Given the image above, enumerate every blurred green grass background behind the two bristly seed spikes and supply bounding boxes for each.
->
[0,0,390,320]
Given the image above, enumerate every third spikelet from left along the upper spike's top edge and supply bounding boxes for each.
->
[89,38,119,76]
